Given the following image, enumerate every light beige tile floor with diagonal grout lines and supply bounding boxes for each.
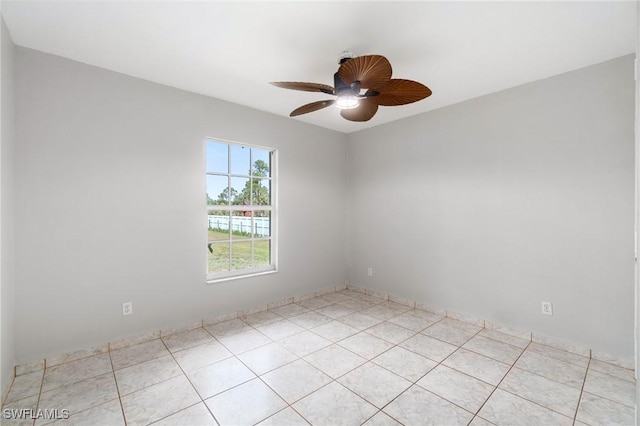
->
[2,290,635,426]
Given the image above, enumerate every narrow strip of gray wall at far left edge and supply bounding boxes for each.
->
[0,15,16,396]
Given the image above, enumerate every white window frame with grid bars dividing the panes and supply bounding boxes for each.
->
[203,137,278,284]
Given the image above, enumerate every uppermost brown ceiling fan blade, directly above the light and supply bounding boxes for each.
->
[338,55,392,90]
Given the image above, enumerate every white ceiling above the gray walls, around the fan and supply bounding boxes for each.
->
[2,0,636,133]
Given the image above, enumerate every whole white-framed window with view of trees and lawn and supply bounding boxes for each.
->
[206,139,276,281]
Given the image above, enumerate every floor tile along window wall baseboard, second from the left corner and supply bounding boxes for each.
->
[42,353,112,392]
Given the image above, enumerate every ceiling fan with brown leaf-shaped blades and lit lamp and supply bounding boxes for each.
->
[271,52,431,121]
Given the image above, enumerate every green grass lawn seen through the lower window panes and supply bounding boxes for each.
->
[208,230,271,272]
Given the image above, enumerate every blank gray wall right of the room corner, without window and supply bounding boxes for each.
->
[347,56,635,359]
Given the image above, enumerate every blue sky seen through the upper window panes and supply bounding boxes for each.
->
[206,140,270,205]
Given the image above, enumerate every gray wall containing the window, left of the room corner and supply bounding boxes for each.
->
[15,48,346,362]
